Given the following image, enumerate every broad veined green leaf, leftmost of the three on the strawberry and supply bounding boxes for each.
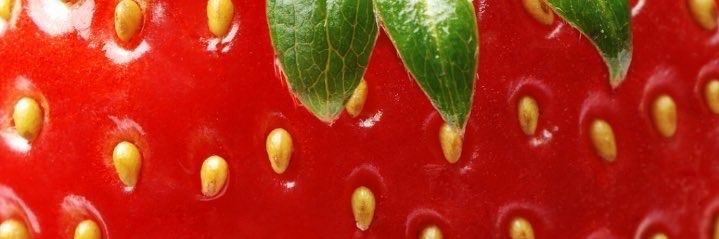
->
[267,0,378,122]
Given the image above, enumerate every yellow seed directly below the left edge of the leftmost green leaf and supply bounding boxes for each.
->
[265,128,293,174]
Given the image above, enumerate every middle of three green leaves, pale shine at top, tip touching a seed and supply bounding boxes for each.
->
[374,0,479,128]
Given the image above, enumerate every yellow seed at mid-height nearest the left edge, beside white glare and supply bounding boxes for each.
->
[12,97,44,140]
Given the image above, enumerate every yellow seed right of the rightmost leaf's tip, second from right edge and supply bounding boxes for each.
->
[652,95,677,138]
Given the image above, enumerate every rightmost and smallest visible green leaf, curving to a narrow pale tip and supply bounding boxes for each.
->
[547,0,632,88]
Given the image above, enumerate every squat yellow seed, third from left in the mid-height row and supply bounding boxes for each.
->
[200,156,229,197]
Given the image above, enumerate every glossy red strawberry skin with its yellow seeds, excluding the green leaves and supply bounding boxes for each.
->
[0,0,719,238]
